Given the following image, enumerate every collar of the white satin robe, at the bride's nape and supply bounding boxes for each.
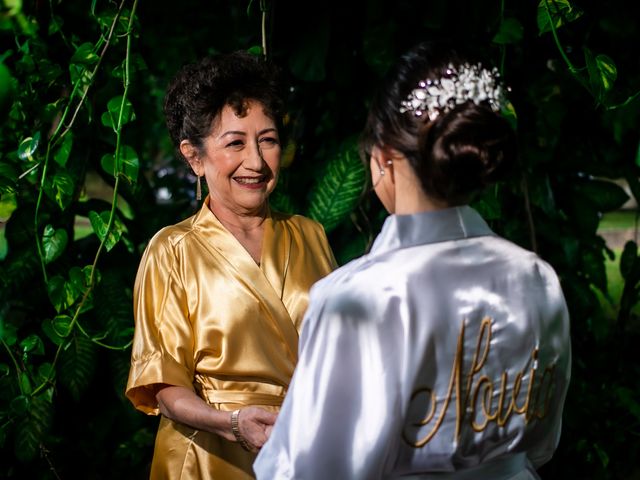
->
[371,205,495,254]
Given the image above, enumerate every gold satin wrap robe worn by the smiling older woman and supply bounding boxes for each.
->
[126,199,336,480]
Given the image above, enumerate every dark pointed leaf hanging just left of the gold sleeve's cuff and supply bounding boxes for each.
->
[58,335,96,401]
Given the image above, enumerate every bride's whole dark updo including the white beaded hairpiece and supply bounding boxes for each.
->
[361,42,516,206]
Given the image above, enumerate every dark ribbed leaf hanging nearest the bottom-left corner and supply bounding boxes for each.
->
[14,395,54,462]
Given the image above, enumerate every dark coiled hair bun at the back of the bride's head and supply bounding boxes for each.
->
[418,102,517,205]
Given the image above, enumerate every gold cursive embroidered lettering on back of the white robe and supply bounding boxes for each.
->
[402,317,556,448]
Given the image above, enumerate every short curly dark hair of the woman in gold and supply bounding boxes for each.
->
[164,51,283,158]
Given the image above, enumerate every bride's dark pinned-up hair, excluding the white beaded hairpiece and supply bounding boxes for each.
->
[361,42,517,205]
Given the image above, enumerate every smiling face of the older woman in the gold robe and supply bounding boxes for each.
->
[187,102,280,216]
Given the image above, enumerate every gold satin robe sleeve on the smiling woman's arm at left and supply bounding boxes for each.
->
[126,232,194,415]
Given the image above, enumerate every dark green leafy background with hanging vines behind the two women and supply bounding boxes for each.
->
[0,0,640,479]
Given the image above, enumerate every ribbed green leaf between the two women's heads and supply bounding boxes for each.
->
[308,140,366,232]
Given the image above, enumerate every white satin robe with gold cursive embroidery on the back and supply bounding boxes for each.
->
[254,206,571,480]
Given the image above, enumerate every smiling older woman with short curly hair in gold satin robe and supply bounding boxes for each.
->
[126,52,335,479]
